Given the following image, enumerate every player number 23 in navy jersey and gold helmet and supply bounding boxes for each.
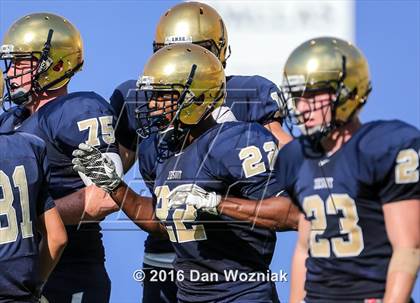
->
[276,37,420,303]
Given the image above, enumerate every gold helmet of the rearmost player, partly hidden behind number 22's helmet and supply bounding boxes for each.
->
[153,2,230,66]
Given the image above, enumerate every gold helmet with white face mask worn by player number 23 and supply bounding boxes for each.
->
[283,37,371,135]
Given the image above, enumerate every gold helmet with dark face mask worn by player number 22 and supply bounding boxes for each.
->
[137,44,226,137]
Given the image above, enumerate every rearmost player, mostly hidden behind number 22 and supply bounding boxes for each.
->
[110,2,290,302]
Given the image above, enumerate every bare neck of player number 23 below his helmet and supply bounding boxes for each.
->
[321,118,362,155]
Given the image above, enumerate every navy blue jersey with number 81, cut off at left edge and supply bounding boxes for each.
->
[0,132,54,302]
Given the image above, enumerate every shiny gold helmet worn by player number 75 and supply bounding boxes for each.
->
[0,13,83,103]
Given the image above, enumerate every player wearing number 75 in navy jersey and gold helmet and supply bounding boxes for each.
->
[0,13,122,303]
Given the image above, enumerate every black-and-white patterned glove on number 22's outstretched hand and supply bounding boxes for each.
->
[72,143,121,193]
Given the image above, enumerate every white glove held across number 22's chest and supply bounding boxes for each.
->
[168,184,222,215]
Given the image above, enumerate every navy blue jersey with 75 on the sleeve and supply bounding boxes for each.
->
[0,92,118,263]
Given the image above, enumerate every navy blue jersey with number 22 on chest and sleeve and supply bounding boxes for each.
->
[154,122,278,302]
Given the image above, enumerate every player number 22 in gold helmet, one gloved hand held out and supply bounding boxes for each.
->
[73,44,296,302]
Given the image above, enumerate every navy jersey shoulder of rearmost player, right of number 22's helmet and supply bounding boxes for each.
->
[225,76,280,125]
